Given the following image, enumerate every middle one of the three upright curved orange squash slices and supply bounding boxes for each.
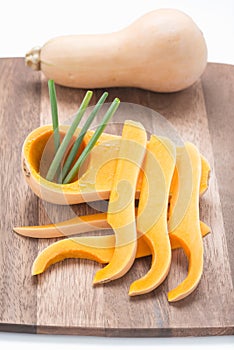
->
[129,136,176,296]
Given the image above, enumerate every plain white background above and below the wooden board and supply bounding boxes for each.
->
[0,0,234,350]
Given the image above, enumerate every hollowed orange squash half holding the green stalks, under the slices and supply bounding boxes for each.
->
[22,125,210,204]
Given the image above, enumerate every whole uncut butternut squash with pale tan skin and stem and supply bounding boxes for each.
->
[25,9,207,92]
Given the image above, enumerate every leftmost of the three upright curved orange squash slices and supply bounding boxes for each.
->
[93,121,147,284]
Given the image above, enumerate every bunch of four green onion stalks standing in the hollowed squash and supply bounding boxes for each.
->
[46,80,120,184]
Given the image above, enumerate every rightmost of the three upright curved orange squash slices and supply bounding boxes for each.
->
[168,143,203,301]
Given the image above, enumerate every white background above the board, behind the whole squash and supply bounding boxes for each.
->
[0,0,234,64]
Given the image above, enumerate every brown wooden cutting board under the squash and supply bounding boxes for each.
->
[0,58,234,337]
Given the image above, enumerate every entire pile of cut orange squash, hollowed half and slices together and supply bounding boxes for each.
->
[14,120,210,302]
